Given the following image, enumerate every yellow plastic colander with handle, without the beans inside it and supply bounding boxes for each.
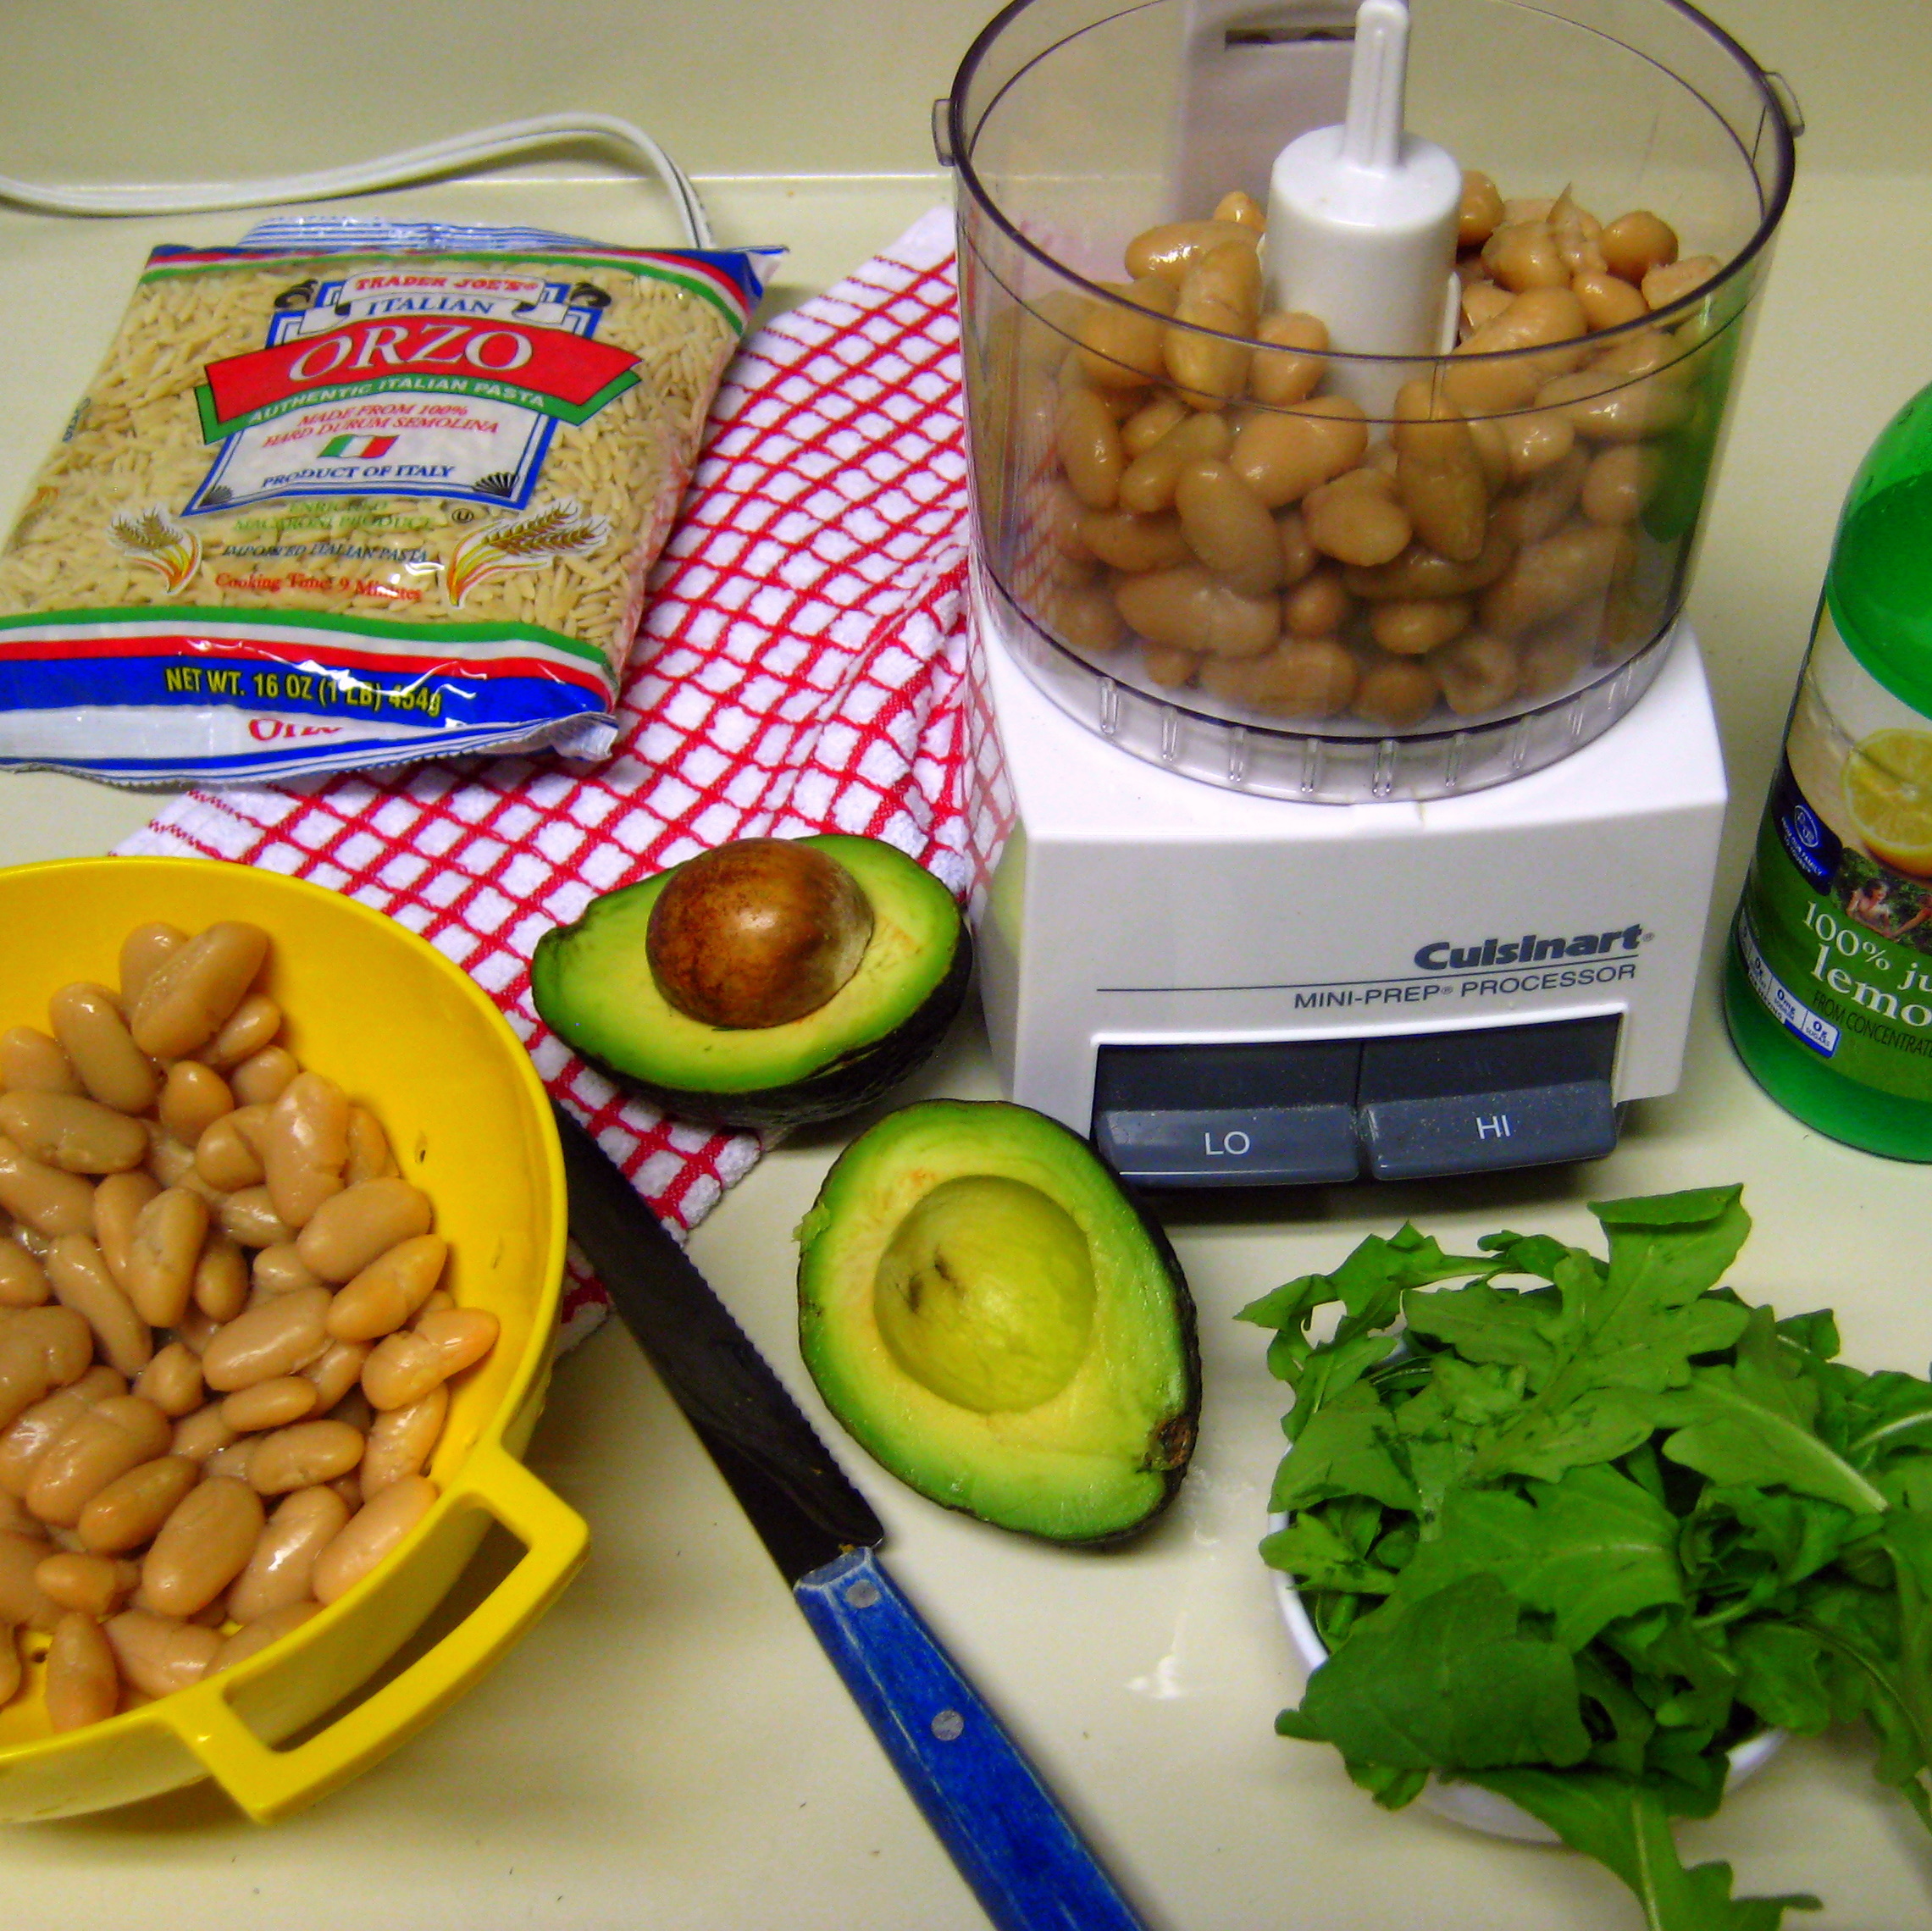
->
[0,860,585,1823]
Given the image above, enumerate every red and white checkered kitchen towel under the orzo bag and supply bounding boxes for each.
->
[119,211,968,1334]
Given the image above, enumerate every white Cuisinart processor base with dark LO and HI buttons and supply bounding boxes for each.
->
[972,575,1725,1187]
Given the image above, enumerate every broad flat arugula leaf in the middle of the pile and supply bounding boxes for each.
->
[1377,1468,1686,1651]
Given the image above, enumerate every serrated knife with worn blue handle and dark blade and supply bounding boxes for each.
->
[556,1106,1146,1931]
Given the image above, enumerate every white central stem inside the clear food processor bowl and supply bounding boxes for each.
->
[1261,0,1463,419]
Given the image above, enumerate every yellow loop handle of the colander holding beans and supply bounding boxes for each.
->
[157,1442,590,1823]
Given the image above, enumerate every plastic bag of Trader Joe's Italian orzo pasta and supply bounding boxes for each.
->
[0,219,778,784]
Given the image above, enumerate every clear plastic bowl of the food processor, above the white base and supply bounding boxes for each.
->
[935,0,1799,801]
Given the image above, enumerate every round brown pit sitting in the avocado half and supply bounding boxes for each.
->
[645,838,873,1032]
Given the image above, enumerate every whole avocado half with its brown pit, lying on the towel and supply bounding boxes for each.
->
[529,833,972,1128]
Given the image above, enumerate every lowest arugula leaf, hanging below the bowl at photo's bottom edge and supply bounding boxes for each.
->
[1466,1768,1818,1931]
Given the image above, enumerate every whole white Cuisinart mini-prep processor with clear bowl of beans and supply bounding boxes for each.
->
[935,0,1801,1187]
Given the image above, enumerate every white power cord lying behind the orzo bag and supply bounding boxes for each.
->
[0,114,711,247]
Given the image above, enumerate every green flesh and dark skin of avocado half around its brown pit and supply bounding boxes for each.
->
[529,833,972,1128]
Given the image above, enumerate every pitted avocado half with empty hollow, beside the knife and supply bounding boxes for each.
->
[798,1101,1200,1543]
